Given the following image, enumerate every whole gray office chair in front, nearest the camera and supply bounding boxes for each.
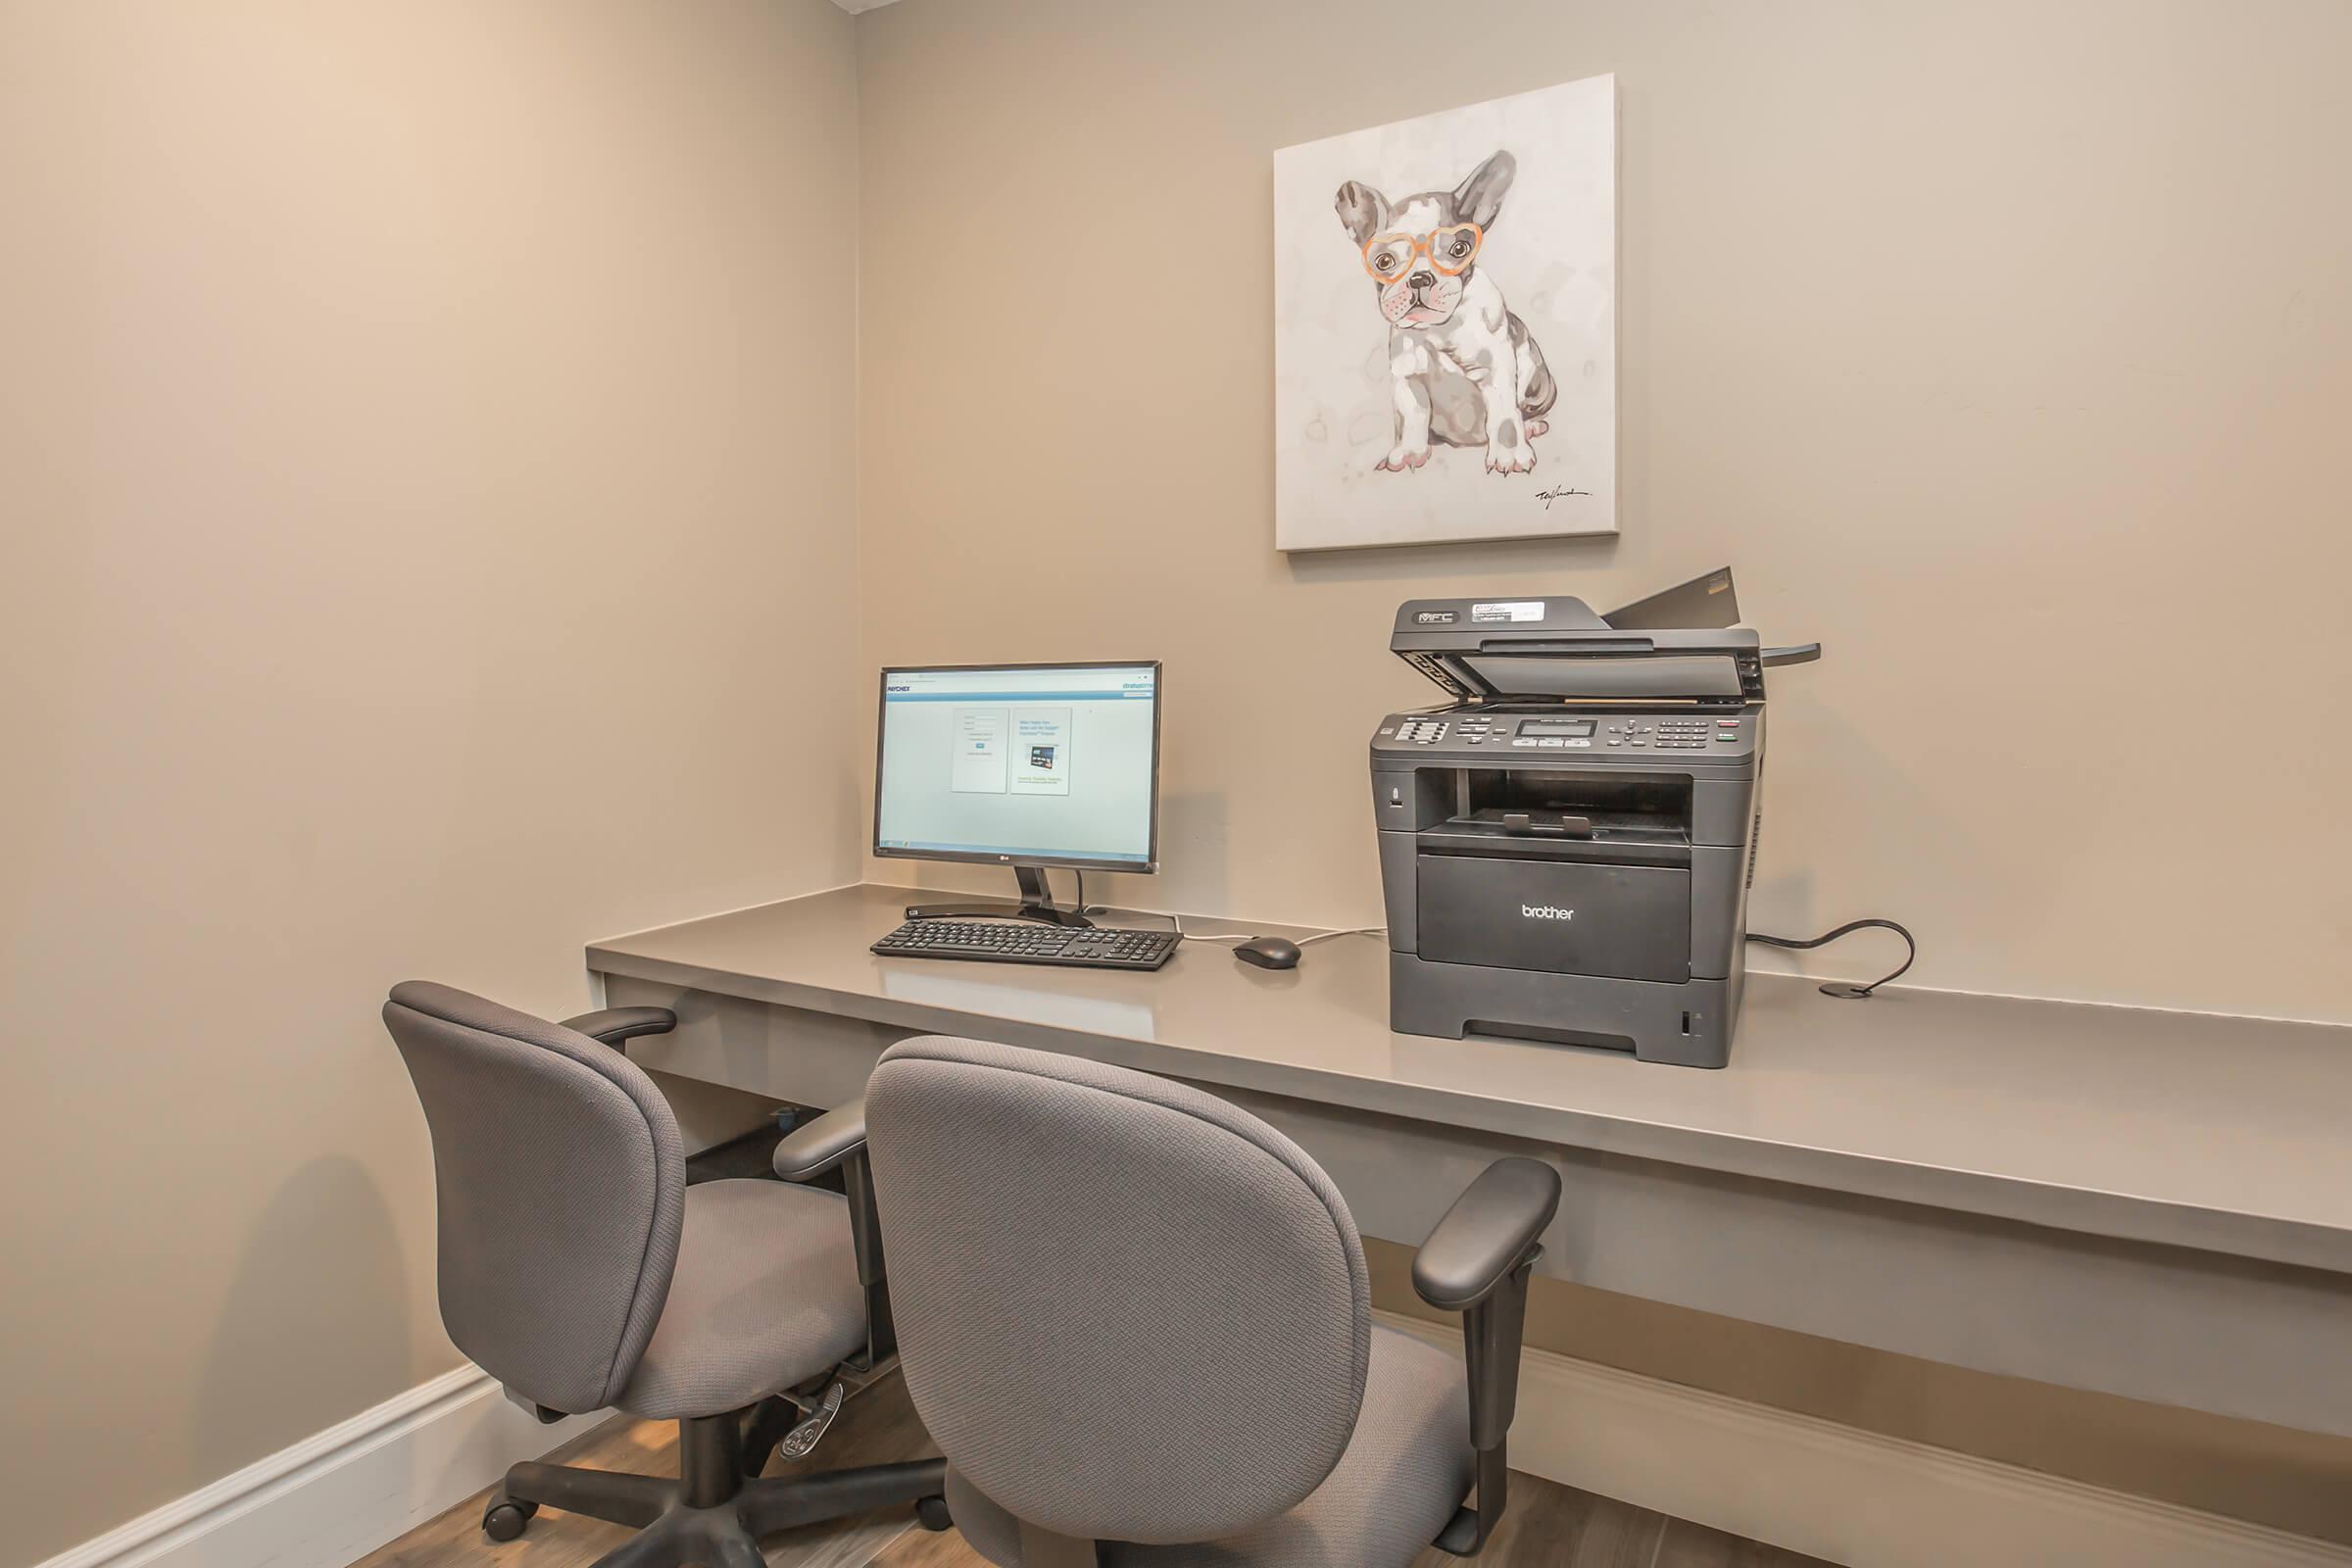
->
[863,1037,1559,1568]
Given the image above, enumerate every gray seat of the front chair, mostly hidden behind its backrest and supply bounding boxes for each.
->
[948,1324,1475,1568]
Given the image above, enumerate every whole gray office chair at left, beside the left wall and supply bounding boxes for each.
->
[383,983,946,1568]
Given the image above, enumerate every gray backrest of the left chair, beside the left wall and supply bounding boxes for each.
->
[383,980,687,1413]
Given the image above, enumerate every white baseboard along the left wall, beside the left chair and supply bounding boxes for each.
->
[37,1366,602,1568]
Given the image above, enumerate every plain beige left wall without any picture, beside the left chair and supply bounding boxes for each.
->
[0,0,863,1563]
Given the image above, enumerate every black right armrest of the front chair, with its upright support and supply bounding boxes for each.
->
[1413,1159,1559,1556]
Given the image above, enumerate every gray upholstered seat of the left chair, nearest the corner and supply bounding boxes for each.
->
[613,1180,865,1420]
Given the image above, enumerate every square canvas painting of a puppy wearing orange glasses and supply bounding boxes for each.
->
[1275,77,1616,550]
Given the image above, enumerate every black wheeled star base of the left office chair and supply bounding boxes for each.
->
[482,1415,948,1568]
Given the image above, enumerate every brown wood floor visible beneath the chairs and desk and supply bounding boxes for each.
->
[353,1373,1828,1568]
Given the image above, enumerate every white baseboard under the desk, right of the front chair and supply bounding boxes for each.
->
[1378,1312,2352,1568]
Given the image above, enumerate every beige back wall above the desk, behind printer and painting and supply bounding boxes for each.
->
[858,0,2352,1020]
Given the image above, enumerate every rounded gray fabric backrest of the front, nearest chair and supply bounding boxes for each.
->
[865,1037,1371,1543]
